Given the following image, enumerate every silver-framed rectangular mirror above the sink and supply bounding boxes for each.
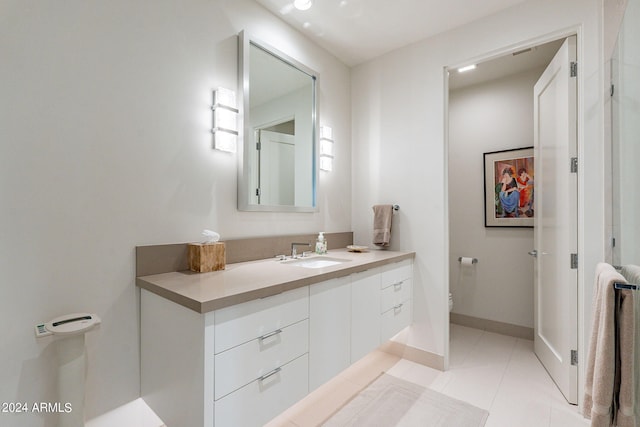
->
[238,31,319,212]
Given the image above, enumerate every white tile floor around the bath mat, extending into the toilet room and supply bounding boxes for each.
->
[269,325,589,427]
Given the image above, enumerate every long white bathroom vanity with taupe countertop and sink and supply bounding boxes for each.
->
[136,250,414,427]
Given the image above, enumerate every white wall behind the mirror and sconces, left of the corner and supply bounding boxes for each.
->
[0,0,351,427]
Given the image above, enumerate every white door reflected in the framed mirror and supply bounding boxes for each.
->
[258,130,296,206]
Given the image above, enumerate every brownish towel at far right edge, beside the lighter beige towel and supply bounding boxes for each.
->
[616,265,640,427]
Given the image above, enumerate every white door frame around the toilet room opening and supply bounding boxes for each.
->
[442,25,591,408]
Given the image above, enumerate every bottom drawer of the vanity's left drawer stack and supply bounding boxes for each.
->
[215,354,309,427]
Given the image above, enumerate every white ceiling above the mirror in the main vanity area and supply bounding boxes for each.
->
[255,0,525,66]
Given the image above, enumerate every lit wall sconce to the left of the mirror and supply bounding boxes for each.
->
[211,87,238,153]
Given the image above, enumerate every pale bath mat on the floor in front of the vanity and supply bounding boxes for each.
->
[323,373,489,427]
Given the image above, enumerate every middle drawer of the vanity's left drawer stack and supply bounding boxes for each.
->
[214,319,309,400]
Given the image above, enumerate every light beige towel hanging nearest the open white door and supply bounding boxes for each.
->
[583,263,625,427]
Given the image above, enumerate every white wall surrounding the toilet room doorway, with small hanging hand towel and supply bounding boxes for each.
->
[352,0,605,398]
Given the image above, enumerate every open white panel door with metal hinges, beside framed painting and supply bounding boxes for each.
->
[532,36,578,404]
